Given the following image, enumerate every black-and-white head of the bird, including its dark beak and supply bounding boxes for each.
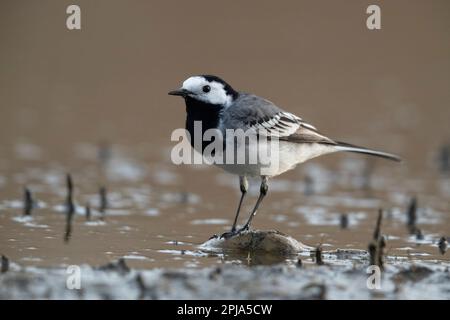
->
[169,75,238,107]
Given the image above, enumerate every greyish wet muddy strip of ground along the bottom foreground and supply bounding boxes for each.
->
[0,242,450,300]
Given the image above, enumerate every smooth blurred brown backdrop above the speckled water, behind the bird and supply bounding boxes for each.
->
[0,0,450,169]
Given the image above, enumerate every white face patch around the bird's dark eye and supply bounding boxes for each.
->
[182,76,233,107]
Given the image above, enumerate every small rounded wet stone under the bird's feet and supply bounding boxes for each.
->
[200,230,311,256]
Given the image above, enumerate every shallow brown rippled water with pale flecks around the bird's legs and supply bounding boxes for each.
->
[0,141,450,268]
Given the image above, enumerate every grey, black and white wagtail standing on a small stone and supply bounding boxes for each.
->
[169,75,400,237]
